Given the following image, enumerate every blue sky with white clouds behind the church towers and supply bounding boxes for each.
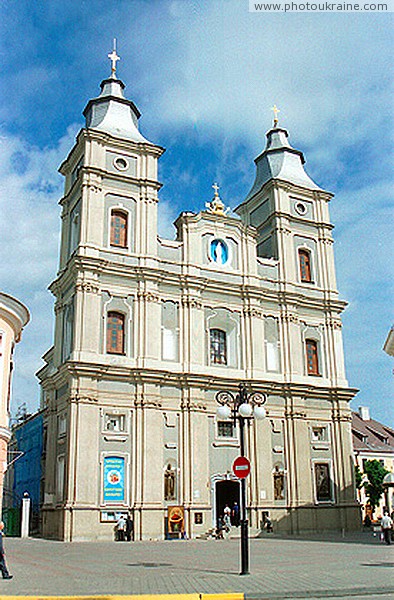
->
[0,0,394,427]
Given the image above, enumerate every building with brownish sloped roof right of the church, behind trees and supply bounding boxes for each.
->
[352,406,394,518]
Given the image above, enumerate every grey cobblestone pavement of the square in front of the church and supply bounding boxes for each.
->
[0,532,394,600]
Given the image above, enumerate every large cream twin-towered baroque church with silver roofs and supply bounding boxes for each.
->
[38,55,359,540]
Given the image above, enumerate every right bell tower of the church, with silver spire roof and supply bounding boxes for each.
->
[236,112,337,298]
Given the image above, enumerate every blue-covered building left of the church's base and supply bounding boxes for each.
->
[3,411,44,533]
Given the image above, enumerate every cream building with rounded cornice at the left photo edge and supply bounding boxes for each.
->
[0,292,30,513]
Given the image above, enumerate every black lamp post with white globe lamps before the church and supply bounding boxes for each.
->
[216,383,267,575]
